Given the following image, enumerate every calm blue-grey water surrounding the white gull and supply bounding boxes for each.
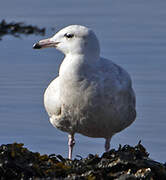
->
[0,0,166,162]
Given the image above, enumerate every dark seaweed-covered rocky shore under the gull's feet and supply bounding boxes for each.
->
[0,142,166,180]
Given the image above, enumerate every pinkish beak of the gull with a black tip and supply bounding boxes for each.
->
[33,38,59,49]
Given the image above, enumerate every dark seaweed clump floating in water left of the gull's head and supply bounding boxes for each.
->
[0,19,45,40]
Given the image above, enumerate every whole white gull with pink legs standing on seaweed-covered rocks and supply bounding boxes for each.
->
[33,25,136,159]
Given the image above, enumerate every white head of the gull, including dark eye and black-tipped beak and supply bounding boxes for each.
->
[33,25,100,56]
